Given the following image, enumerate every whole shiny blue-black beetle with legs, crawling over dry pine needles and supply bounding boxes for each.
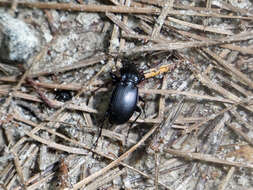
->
[95,63,144,147]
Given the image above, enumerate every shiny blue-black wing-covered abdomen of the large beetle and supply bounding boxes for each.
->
[109,83,138,124]
